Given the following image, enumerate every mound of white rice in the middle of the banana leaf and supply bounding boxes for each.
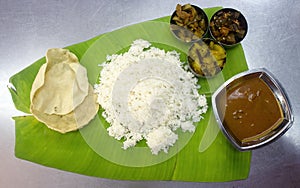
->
[95,39,208,155]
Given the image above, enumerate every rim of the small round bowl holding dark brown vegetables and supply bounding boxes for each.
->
[208,8,248,47]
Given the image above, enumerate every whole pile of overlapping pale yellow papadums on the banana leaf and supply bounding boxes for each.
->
[30,48,99,133]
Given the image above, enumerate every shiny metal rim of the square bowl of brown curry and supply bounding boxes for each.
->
[211,68,294,151]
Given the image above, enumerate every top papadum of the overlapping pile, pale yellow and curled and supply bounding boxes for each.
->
[30,48,89,115]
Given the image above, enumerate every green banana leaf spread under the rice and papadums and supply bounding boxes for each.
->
[9,7,251,182]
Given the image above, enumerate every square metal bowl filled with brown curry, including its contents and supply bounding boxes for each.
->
[212,68,294,151]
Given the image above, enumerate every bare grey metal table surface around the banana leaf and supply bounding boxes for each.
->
[0,0,300,188]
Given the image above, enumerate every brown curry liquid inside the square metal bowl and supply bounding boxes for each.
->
[217,76,283,145]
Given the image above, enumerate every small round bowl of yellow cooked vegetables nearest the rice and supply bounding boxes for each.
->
[188,38,227,78]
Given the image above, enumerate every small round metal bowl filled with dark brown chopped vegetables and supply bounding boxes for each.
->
[209,8,248,48]
